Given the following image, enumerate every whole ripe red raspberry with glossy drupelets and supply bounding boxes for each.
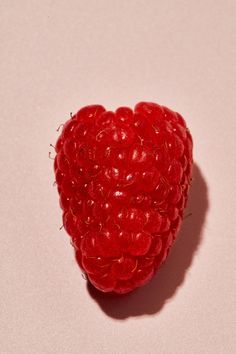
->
[54,102,193,294]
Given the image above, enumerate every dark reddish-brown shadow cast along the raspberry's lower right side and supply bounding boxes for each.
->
[87,164,208,320]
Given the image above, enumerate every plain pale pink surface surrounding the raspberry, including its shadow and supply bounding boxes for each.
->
[0,0,236,354]
